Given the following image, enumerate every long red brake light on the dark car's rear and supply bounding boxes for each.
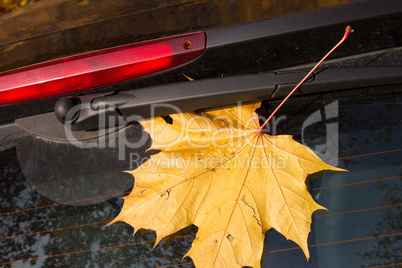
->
[0,33,205,105]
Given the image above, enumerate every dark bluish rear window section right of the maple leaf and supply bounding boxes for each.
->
[263,87,402,267]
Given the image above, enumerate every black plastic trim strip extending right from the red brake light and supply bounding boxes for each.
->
[207,0,402,48]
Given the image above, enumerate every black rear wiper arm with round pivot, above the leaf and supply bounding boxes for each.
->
[51,66,402,131]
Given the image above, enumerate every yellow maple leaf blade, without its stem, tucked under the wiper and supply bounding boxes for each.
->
[112,103,342,267]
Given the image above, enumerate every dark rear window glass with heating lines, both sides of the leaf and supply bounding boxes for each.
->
[0,85,402,268]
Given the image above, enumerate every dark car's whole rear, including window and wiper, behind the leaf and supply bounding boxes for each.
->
[0,0,402,267]
